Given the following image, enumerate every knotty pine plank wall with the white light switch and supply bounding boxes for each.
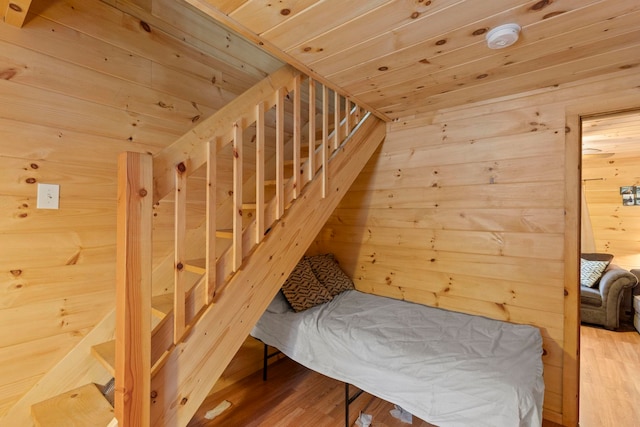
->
[0,0,281,418]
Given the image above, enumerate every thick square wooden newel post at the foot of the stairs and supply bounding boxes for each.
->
[115,152,153,427]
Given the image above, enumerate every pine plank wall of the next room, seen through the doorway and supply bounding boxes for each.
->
[582,154,640,270]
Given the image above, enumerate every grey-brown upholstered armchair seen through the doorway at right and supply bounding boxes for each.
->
[580,254,638,330]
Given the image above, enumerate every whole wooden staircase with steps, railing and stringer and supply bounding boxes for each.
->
[27,66,386,427]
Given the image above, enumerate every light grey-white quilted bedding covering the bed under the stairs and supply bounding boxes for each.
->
[251,291,544,427]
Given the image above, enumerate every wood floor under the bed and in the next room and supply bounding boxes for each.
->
[189,326,640,427]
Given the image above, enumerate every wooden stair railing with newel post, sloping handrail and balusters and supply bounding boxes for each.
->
[116,66,372,427]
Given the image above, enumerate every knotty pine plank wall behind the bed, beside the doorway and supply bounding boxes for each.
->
[309,67,640,425]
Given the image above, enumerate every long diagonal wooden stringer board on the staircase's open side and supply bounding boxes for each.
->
[151,116,386,427]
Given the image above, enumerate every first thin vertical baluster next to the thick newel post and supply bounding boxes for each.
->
[173,163,187,344]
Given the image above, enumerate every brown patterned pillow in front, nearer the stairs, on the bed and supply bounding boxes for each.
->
[282,258,333,312]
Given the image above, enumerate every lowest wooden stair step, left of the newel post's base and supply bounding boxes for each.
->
[31,383,114,427]
